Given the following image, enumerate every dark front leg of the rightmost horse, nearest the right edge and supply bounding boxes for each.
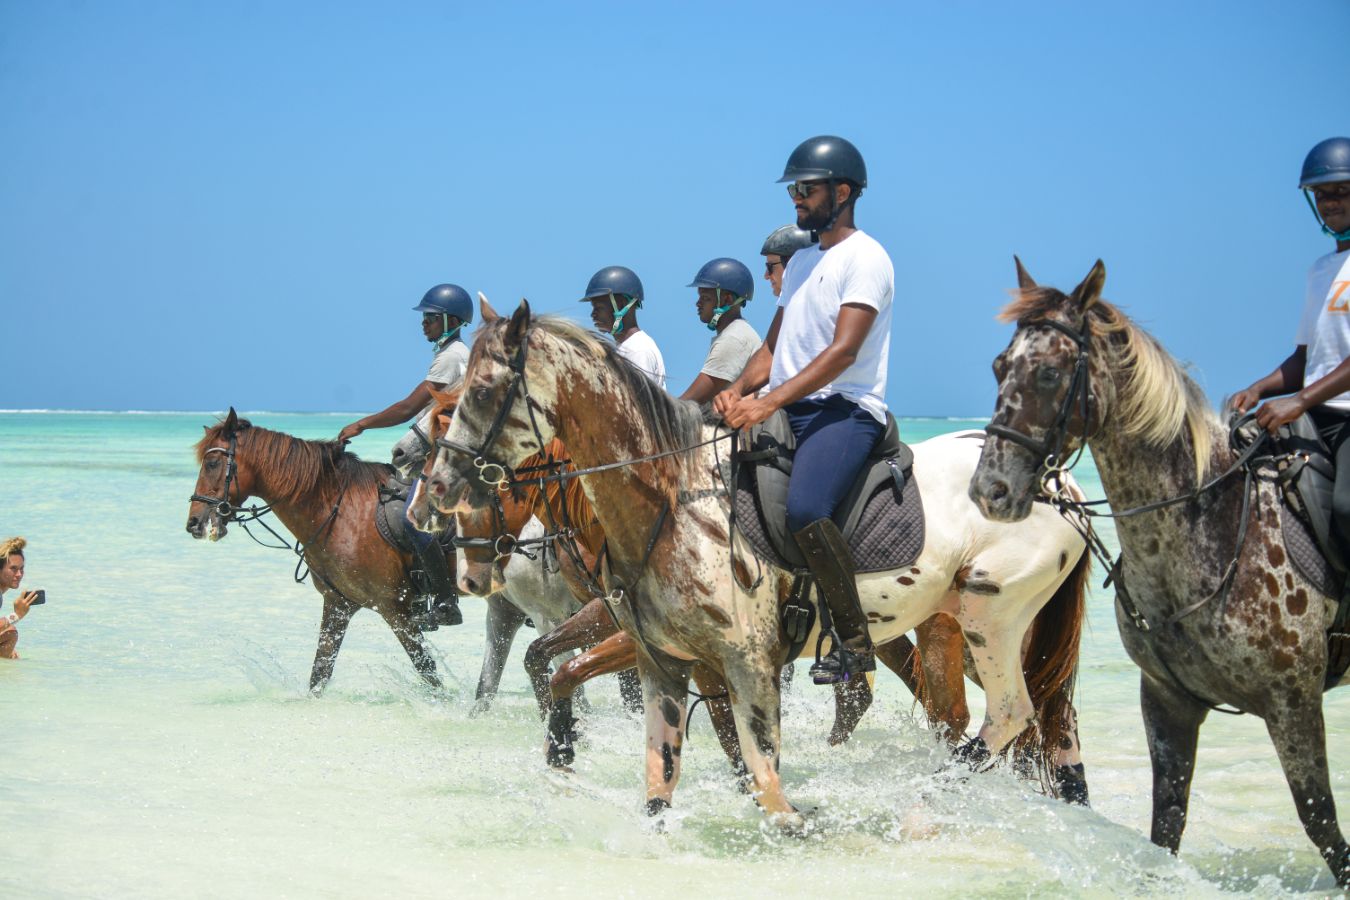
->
[1265,690,1350,888]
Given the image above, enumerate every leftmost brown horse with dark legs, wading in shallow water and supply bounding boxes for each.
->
[188,409,440,695]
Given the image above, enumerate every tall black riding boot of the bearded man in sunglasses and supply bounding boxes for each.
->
[792,518,876,684]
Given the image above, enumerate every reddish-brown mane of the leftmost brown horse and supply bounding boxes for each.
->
[194,418,389,503]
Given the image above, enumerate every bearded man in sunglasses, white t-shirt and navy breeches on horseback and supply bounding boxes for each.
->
[713,135,895,684]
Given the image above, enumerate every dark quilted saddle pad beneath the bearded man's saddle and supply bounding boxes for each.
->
[736,466,923,572]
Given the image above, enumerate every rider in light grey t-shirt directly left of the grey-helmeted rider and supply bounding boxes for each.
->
[679,256,760,403]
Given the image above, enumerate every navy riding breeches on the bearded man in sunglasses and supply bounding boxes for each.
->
[783,394,884,534]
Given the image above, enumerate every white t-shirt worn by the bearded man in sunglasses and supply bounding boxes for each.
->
[768,231,895,424]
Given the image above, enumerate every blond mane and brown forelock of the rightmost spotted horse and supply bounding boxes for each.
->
[999,286,1219,480]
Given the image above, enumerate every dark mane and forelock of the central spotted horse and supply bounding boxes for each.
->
[468,314,705,504]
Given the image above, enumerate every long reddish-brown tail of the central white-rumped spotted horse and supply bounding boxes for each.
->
[1013,548,1092,787]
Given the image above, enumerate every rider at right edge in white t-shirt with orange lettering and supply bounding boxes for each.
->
[1231,138,1350,671]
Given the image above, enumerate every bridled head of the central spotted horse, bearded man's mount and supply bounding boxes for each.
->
[427,294,558,513]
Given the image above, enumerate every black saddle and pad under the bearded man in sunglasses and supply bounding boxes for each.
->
[734,410,923,572]
